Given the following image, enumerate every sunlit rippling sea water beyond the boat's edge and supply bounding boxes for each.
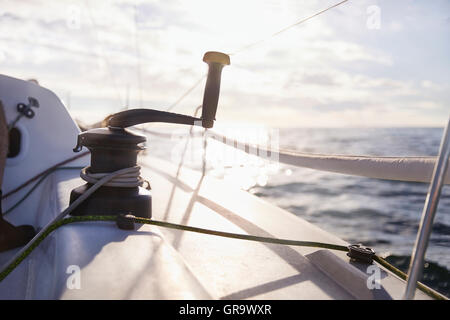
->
[146,128,450,296]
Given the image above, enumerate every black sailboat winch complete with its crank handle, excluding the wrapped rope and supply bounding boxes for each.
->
[70,51,230,218]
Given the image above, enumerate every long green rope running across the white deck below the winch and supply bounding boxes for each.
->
[0,216,447,300]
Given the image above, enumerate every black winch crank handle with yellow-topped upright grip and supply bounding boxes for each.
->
[108,51,230,128]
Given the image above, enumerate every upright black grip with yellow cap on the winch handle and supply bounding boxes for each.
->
[201,51,230,128]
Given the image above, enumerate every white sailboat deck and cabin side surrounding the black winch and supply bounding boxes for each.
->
[0,76,428,299]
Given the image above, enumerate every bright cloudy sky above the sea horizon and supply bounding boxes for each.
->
[0,0,450,127]
